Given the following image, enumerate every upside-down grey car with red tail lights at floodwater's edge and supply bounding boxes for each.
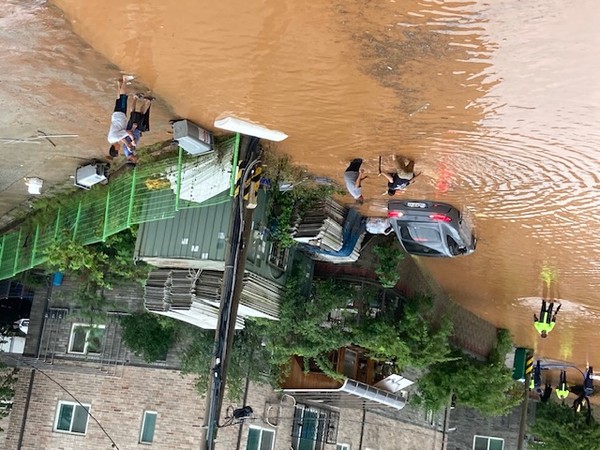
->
[388,200,477,257]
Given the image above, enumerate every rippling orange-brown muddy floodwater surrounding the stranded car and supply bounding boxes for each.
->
[54,0,600,372]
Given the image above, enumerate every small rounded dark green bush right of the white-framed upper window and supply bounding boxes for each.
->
[121,312,177,363]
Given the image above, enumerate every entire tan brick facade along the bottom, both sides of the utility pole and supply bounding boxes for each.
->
[4,364,441,450]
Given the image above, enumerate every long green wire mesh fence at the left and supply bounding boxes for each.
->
[0,136,239,280]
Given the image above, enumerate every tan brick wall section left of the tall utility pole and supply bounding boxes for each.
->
[6,367,217,450]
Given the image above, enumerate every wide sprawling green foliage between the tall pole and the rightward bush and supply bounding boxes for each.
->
[257,268,452,378]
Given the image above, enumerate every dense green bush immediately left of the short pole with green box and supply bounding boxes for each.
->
[418,332,523,416]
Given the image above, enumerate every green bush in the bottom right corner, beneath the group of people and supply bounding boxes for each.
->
[528,401,600,450]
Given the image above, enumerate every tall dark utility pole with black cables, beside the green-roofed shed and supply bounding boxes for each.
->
[200,136,260,450]
